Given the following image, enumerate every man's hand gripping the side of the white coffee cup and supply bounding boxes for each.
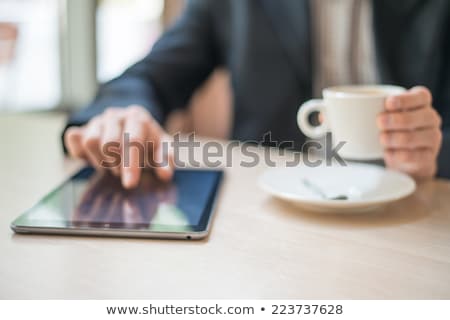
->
[377,87,442,180]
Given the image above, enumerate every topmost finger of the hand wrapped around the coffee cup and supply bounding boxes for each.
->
[386,86,433,111]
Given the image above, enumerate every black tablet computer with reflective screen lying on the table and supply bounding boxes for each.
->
[11,167,223,239]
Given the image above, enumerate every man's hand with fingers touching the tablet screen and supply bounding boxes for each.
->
[64,106,173,188]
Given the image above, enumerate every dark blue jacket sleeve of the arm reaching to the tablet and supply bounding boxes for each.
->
[64,0,217,131]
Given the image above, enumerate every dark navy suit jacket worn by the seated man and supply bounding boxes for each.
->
[68,0,450,177]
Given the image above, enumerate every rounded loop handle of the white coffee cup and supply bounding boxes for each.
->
[297,99,328,139]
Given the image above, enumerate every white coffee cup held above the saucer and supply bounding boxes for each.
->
[297,85,405,160]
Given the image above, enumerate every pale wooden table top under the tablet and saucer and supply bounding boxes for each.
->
[0,114,450,299]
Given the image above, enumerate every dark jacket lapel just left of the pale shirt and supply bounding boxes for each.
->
[261,0,312,95]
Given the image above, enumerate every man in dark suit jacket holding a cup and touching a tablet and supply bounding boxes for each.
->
[64,0,450,188]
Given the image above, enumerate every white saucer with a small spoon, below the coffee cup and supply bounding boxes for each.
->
[259,164,416,213]
